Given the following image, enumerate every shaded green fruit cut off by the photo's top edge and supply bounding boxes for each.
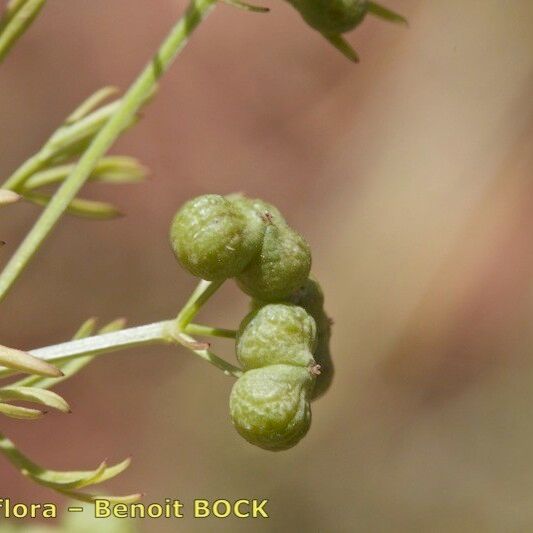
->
[289,0,369,35]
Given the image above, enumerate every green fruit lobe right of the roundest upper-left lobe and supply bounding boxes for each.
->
[237,224,311,302]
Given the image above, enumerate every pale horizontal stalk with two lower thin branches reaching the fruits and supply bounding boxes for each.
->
[0,320,240,378]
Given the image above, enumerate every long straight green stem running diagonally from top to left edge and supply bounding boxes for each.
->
[0,0,216,301]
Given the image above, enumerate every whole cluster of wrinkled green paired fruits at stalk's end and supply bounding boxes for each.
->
[170,194,333,450]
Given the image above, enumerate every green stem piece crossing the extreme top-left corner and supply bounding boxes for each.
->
[0,0,46,63]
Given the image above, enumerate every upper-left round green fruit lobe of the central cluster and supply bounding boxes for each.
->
[170,194,265,280]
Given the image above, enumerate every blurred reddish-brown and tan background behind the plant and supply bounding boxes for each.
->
[0,0,533,532]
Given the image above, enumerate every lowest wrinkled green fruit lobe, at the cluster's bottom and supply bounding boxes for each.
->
[230,365,314,451]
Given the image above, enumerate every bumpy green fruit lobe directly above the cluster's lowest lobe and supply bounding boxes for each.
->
[236,304,316,370]
